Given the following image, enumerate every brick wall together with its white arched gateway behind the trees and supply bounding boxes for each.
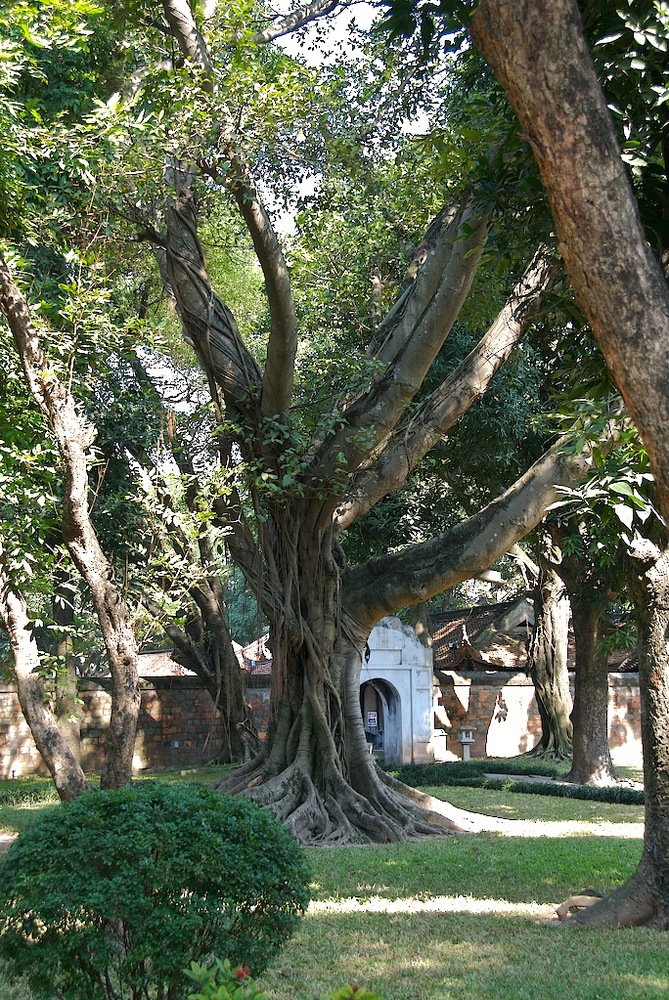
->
[0,618,641,778]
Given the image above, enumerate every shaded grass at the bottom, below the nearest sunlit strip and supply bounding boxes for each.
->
[261,911,669,1000]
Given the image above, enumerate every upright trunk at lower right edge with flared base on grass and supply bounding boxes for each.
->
[574,539,669,930]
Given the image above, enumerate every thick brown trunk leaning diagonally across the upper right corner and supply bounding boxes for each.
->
[471,0,669,521]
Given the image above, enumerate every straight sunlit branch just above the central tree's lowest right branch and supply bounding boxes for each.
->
[337,256,555,530]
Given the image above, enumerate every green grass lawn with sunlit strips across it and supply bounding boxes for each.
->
[0,760,669,1000]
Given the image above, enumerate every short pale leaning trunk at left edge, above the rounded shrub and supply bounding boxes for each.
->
[0,560,88,801]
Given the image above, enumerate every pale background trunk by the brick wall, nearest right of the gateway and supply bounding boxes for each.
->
[527,560,572,760]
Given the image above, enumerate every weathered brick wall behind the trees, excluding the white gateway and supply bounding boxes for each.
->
[0,672,641,778]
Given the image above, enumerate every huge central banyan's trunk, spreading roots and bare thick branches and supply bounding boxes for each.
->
[134,0,600,843]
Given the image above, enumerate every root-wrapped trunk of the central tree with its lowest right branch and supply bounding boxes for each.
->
[213,438,604,844]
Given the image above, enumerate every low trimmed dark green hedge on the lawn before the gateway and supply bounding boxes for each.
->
[385,760,644,806]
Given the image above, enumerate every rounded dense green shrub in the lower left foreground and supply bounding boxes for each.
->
[0,782,309,1000]
